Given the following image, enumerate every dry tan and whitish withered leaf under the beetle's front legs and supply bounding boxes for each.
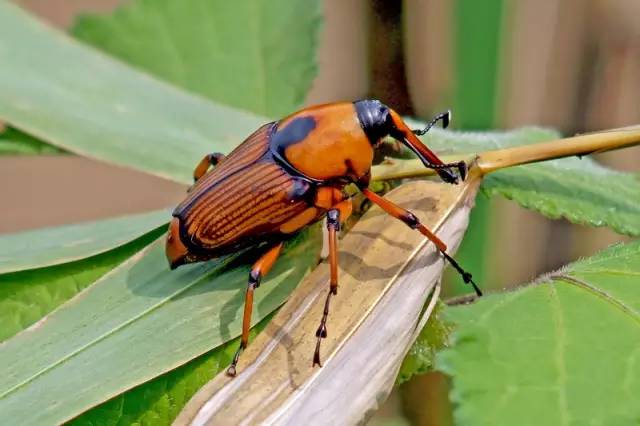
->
[176,176,479,424]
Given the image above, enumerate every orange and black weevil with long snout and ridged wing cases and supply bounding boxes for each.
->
[166,100,481,375]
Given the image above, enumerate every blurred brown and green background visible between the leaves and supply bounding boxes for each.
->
[0,0,640,425]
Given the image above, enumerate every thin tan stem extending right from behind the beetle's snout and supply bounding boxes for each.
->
[372,126,640,181]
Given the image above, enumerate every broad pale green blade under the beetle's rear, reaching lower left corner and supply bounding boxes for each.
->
[0,227,320,424]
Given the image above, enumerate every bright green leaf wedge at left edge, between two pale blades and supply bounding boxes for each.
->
[0,229,163,342]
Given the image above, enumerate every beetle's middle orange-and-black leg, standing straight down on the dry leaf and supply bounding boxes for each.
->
[313,206,342,367]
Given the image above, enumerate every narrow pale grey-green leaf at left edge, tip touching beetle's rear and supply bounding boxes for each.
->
[0,210,171,274]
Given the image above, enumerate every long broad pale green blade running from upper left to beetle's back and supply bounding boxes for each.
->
[0,1,266,183]
